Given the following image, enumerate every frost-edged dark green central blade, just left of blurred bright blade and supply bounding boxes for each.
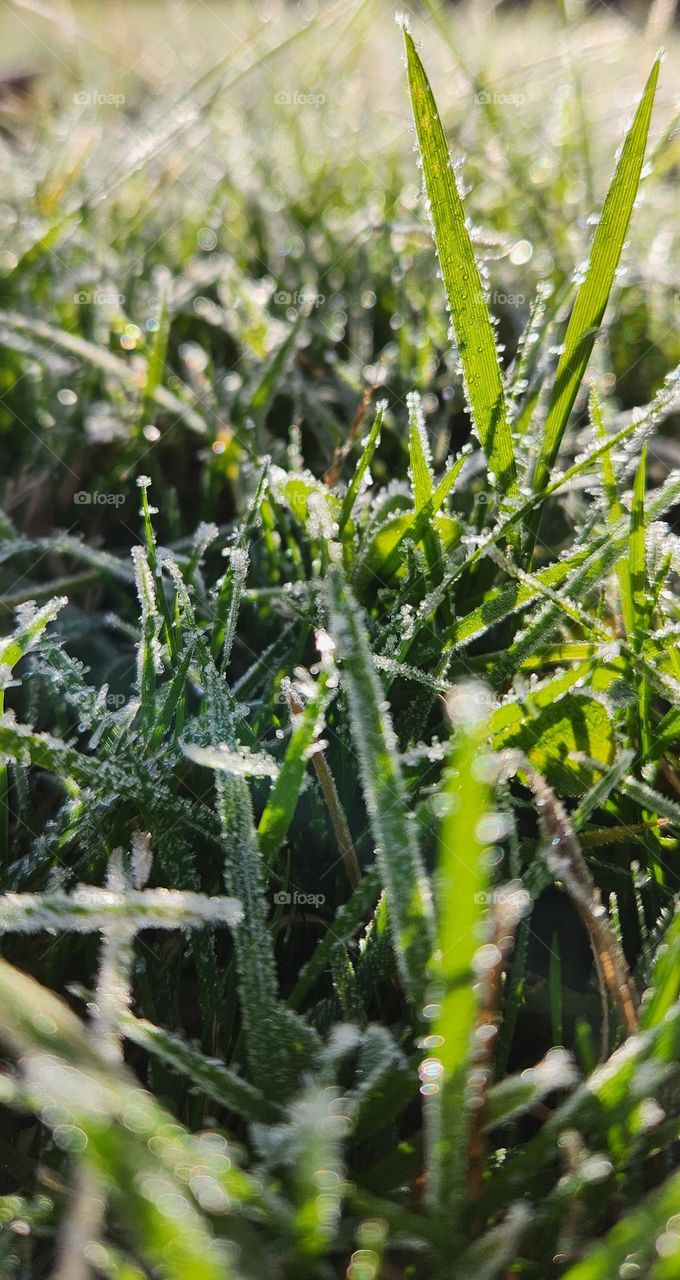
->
[328,572,433,1002]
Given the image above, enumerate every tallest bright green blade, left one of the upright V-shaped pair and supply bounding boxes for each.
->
[403,31,516,493]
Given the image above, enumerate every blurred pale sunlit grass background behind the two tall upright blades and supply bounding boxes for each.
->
[0,0,680,555]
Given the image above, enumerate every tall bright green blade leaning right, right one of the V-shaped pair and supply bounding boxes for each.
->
[533,60,661,492]
